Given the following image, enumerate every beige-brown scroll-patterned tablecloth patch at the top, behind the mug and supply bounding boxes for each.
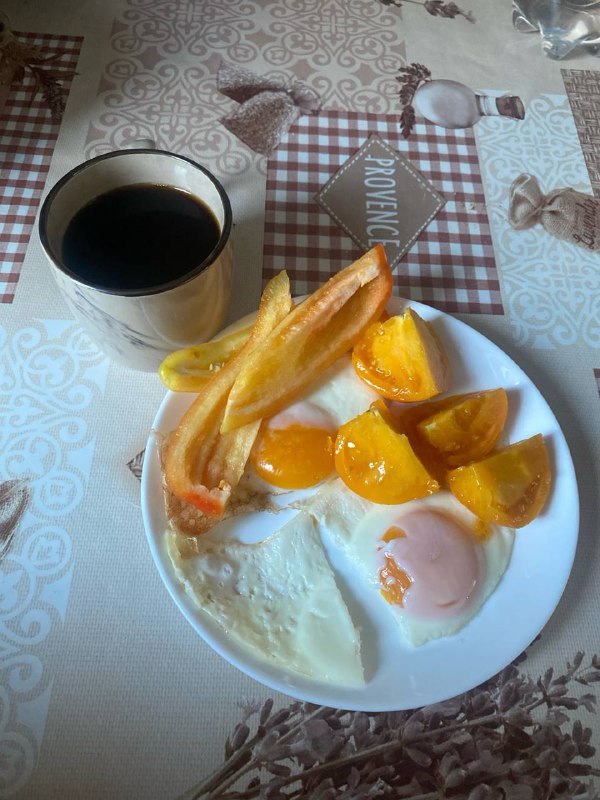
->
[86,0,404,175]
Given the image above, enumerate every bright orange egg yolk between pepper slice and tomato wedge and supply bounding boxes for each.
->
[250,423,334,489]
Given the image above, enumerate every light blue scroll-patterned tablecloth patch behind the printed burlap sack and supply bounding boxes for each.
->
[475,95,600,349]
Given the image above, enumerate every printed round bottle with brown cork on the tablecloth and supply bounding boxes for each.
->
[413,79,525,128]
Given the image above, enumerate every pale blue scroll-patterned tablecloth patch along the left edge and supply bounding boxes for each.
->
[0,320,108,798]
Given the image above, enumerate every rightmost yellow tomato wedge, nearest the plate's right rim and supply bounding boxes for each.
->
[448,433,551,528]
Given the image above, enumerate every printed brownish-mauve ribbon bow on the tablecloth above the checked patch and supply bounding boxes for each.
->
[217,62,320,155]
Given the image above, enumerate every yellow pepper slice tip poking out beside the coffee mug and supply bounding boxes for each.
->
[158,325,252,392]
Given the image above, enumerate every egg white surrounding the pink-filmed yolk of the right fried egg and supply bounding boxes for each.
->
[306,479,514,646]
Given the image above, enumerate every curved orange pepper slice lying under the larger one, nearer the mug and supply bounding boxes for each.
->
[163,272,292,518]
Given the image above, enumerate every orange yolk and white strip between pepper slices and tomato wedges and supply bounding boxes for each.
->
[250,355,378,490]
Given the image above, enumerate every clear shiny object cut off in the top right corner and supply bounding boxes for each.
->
[513,0,600,59]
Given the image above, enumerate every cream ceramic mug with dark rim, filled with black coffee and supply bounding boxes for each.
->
[39,149,232,371]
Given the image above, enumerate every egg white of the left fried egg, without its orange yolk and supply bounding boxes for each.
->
[166,355,378,687]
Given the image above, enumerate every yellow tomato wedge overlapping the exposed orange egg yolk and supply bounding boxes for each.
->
[335,403,439,505]
